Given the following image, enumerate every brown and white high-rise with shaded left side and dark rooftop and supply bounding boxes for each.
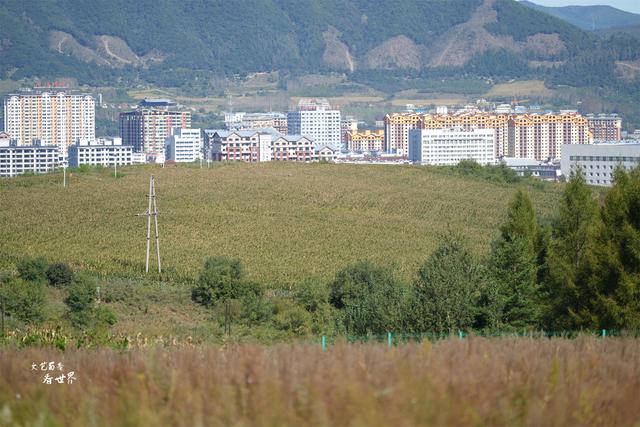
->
[120,108,191,158]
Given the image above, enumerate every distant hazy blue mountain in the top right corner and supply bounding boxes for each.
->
[522,0,640,31]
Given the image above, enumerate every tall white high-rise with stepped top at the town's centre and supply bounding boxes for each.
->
[287,99,342,148]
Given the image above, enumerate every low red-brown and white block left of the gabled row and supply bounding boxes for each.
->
[204,129,272,163]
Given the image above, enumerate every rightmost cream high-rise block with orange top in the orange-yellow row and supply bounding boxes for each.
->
[508,112,592,160]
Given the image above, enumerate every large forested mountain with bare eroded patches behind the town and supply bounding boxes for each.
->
[0,0,640,90]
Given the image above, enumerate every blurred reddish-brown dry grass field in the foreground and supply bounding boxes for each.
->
[0,336,640,426]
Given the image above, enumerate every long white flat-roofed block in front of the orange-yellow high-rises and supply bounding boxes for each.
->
[409,128,496,166]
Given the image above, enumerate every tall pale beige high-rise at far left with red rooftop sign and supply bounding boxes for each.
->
[4,90,96,156]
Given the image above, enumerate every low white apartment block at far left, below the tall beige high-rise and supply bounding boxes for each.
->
[0,132,59,177]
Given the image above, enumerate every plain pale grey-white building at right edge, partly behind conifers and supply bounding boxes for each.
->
[560,143,640,186]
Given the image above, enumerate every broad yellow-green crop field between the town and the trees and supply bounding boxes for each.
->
[0,163,560,287]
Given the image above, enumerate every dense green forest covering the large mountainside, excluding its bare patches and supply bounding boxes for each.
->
[0,0,639,94]
